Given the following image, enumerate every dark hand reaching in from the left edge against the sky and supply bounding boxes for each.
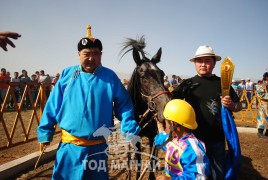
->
[0,32,21,51]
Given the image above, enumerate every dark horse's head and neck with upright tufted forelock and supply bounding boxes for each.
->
[120,37,171,122]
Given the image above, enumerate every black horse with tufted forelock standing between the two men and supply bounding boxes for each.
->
[121,36,171,179]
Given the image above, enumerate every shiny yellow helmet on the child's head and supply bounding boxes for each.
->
[163,99,198,130]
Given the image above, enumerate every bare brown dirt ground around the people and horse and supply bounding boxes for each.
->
[0,109,268,180]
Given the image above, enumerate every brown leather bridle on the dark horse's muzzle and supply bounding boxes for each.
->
[139,91,172,129]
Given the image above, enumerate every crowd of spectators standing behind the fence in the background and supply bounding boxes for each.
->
[0,65,262,111]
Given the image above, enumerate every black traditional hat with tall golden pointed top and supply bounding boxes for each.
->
[77,25,102,51]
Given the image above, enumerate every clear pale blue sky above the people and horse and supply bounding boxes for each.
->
[0,0,268,80]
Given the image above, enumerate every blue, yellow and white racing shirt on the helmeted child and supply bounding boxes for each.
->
[165,133,209,179]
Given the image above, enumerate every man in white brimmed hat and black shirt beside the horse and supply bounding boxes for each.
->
[173,45,242,180]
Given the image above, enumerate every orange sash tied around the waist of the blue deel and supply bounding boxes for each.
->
[61,130,106,146]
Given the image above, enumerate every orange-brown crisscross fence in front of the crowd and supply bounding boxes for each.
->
[0,82,259,149]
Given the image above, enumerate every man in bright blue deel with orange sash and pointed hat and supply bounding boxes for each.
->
[37,26,140,180]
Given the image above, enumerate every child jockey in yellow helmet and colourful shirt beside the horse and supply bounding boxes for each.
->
[155,99,209,180]
